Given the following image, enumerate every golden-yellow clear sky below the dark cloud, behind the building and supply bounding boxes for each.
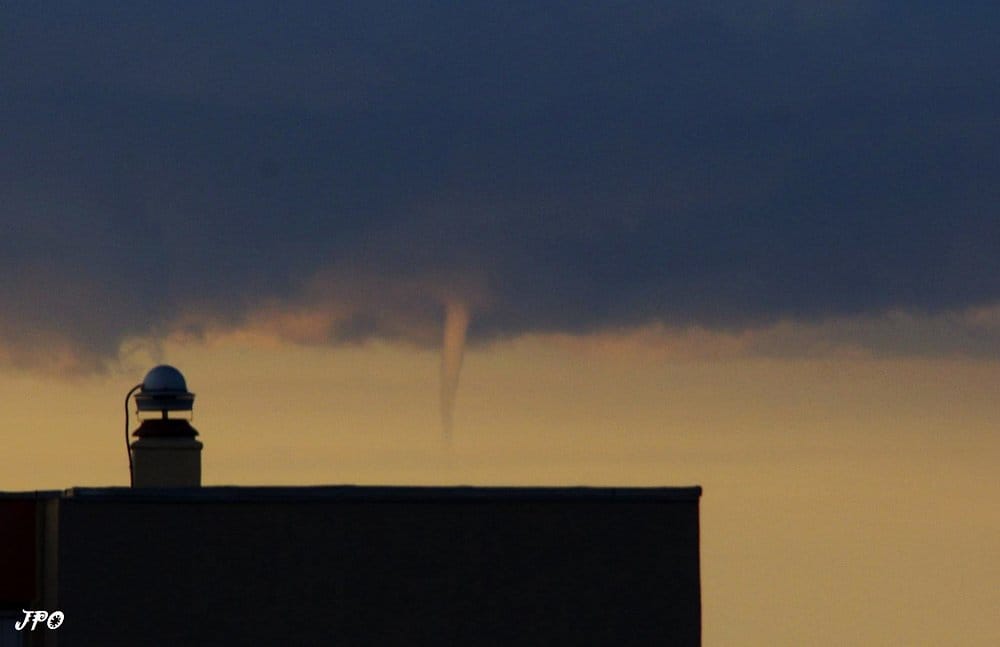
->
[0,333,1000,645]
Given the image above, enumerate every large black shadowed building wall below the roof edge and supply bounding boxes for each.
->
[48,488,701,647]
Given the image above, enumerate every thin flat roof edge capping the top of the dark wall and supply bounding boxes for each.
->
[47,485,701,503]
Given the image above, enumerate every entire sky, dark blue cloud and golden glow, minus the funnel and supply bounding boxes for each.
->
[0,0,1000,645]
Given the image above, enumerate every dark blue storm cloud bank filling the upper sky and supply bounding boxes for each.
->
[0,1,1000,370]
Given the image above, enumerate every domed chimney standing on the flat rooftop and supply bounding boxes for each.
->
[131,365,202,488]
